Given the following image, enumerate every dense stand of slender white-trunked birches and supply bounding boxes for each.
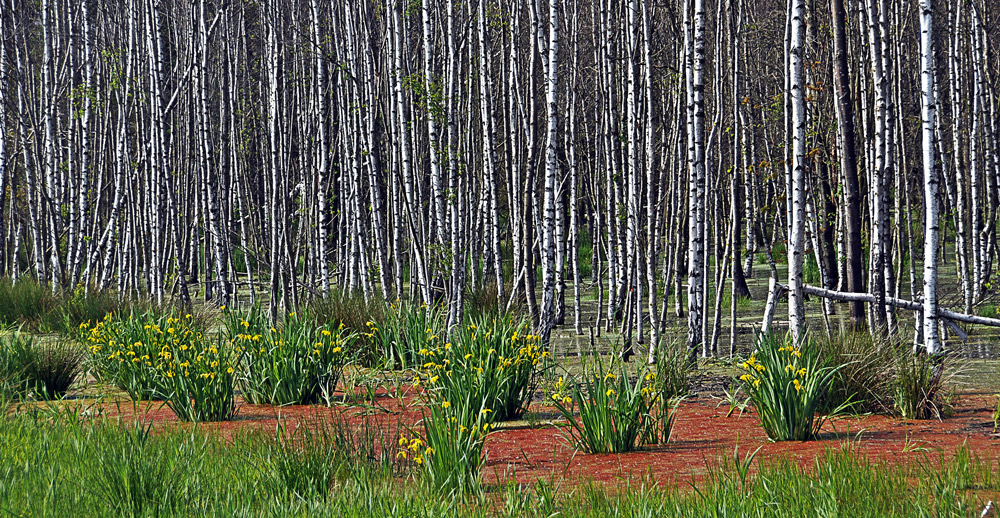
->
[0,0,1000,358]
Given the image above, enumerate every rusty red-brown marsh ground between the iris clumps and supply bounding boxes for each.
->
[47,391,1000,490]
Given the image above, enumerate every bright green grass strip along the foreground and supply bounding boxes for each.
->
[0,410,1000,517]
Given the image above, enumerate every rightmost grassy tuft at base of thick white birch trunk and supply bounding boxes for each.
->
[894,353,953,419]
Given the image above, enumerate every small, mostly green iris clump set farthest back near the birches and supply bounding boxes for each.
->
[362,301,444,369]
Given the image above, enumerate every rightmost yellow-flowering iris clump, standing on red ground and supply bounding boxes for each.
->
[739,335,851,441]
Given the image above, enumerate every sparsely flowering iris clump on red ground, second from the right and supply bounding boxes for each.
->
[551,358,678,453]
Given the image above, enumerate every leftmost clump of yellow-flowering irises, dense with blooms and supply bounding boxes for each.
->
[79,312,191,401]
